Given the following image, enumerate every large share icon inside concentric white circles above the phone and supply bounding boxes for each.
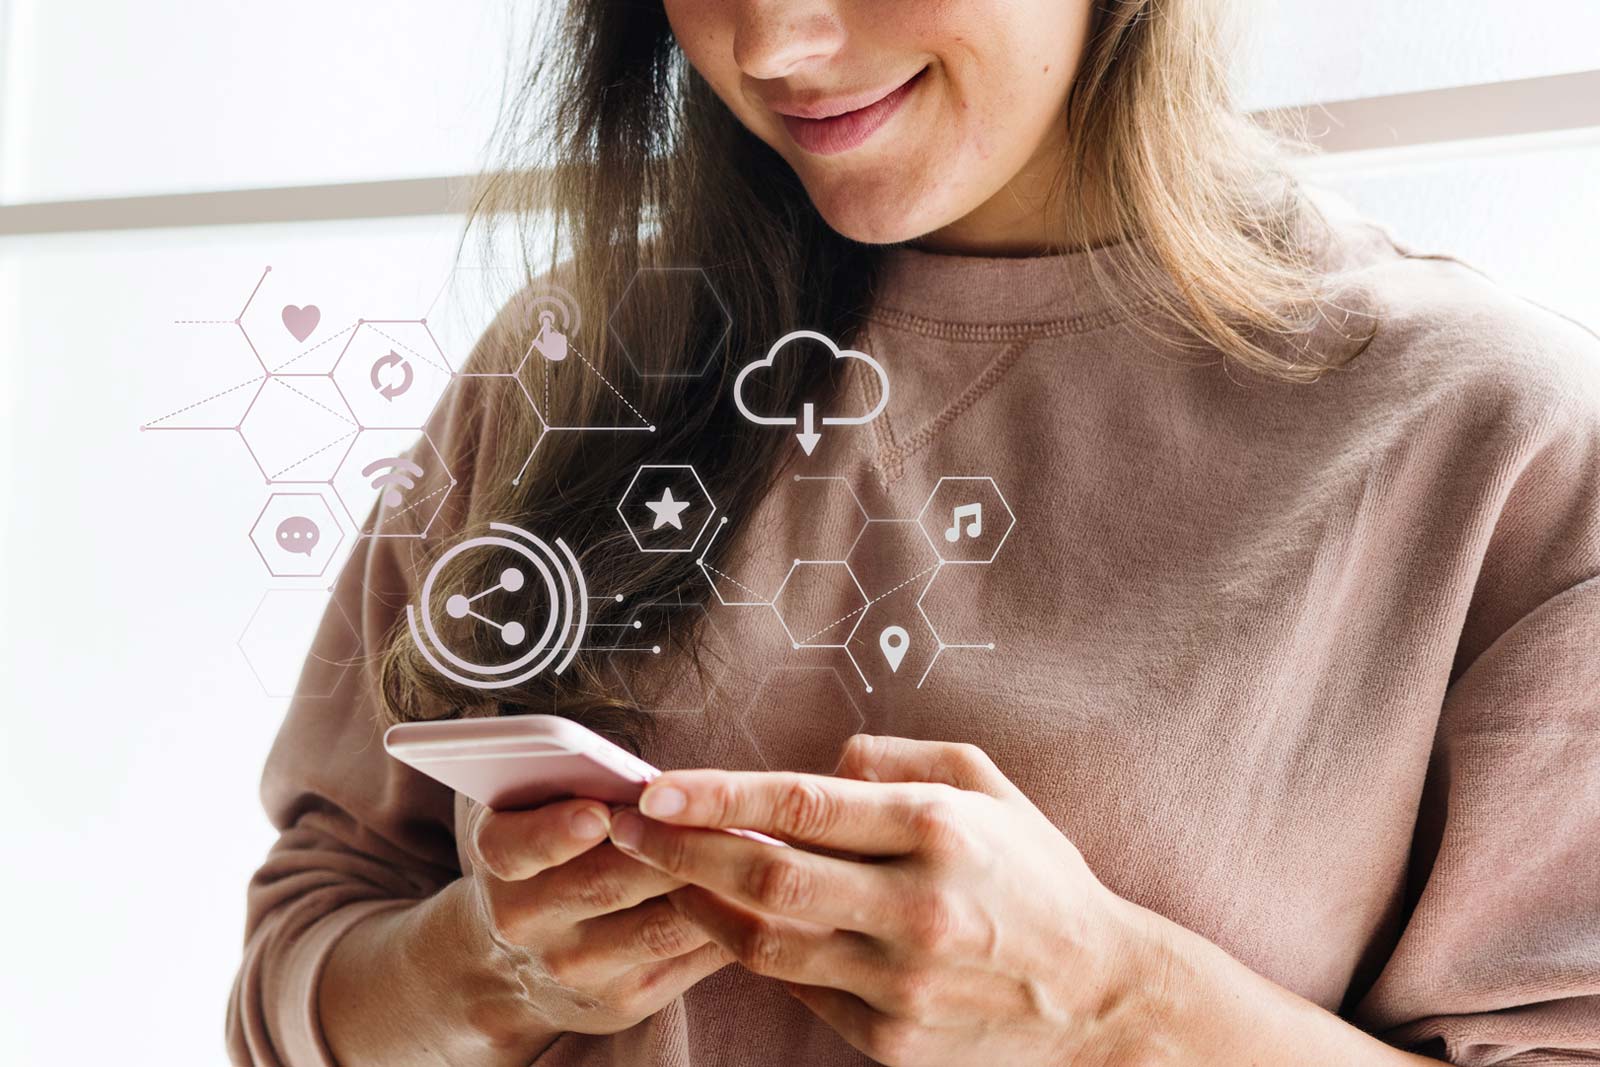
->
[406,523,589,689]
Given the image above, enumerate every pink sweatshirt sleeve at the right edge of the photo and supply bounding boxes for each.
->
[1352,363,1600,1067]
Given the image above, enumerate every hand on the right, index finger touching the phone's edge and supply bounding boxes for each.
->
[611,734,1162,1065]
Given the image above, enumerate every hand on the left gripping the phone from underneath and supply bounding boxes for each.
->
[453,800,733,1048]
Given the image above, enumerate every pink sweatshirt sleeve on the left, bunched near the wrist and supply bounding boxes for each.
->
[227,303,524,1067]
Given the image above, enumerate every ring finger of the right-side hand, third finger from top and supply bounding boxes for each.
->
[670,886,888,992]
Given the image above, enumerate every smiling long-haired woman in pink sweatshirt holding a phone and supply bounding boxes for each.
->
[230,0,1600,1067]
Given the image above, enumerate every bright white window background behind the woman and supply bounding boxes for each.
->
[0,0,1600,1067]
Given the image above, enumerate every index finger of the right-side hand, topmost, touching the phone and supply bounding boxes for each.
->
[638,771,942,856]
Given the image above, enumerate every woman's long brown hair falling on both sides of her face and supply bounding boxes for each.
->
[382,0,1363,741]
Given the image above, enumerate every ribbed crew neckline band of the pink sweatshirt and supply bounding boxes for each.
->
[872,238,1170,331]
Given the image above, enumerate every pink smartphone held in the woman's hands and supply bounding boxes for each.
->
[384,715,782,845]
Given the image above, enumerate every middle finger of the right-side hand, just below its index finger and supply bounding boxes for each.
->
[611,808,906,933]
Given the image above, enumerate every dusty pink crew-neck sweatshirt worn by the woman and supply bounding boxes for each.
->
[229,202,1600,1067]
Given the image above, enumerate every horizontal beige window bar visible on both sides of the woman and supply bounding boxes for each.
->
[0,70,1600,237]
